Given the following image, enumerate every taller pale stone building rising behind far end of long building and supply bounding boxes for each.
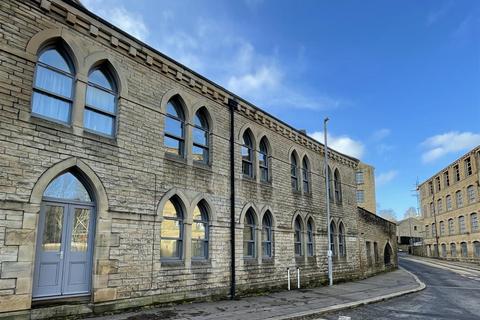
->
[355,162,377,214]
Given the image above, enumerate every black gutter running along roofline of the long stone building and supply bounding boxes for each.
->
[62,0,360,162]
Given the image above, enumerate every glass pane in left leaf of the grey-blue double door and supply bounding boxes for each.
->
[42,206,63,252]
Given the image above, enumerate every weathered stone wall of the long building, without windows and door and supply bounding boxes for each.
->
[0,0,394,312]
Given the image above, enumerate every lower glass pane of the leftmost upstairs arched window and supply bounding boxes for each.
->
[32,92,71,123]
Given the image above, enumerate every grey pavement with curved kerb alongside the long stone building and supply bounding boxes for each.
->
[88,269,425,320]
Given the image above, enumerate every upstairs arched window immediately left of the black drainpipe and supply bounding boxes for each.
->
[192,108,210,164]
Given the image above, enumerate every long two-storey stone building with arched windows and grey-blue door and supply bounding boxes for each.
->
[0,0,396,318]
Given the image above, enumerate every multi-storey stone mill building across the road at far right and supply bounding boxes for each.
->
[419,146,480,262]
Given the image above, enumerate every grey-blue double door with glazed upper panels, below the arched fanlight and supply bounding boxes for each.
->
[33,201,94,299]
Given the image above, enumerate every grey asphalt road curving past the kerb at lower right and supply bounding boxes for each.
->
[322,258,480,320]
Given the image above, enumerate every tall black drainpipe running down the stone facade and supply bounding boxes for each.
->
[228,98,238,300]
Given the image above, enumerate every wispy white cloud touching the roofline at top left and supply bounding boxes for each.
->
[82,0,150,41]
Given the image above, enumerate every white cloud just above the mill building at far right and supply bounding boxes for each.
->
[421,131,480,163]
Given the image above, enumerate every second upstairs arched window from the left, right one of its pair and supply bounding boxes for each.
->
[83,65,117,136]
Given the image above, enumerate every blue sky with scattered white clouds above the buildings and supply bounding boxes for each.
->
[82,0,480,218]
